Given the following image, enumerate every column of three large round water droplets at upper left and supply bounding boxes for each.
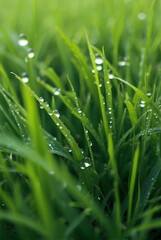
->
[18,33,35,83]
